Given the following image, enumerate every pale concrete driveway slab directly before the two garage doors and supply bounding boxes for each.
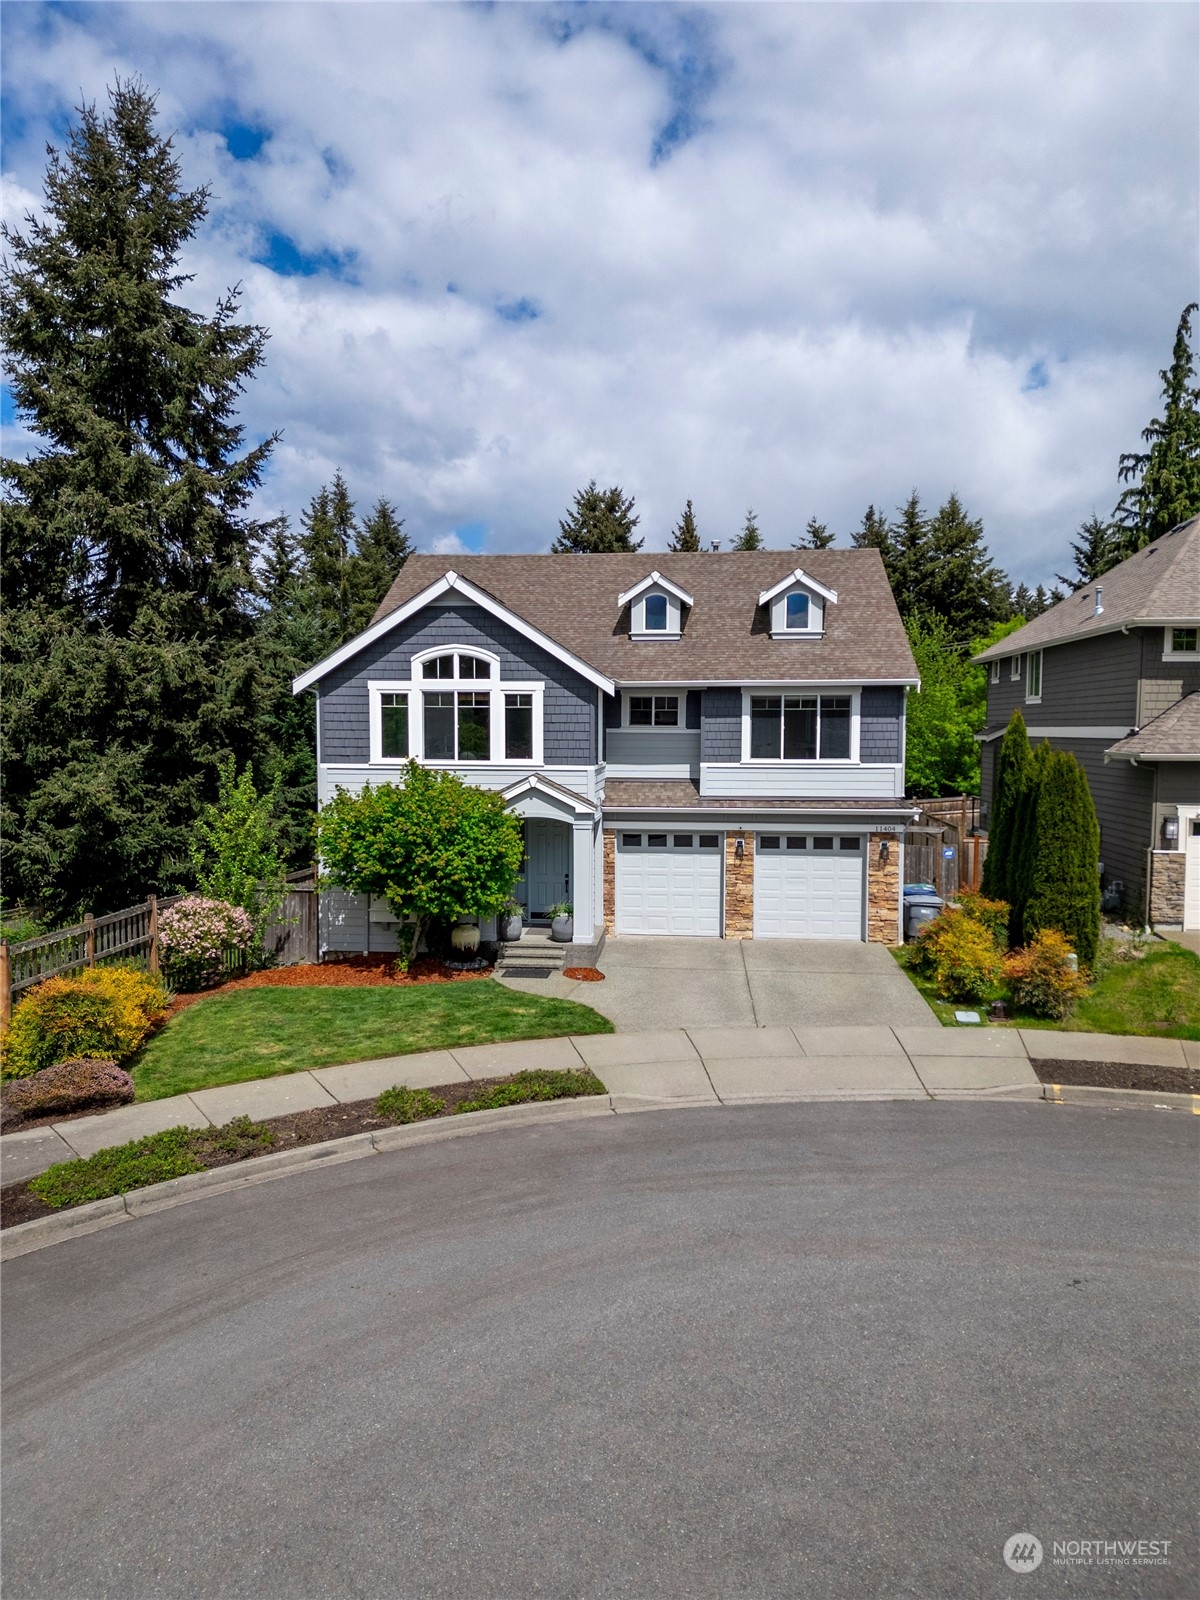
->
[569,938,938,1032]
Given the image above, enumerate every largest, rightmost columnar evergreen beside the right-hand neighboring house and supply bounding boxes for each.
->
[1021,750,1099,968]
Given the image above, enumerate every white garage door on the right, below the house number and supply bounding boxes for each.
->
[754,834,866,939]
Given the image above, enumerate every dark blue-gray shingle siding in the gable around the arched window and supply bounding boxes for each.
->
[320,605,597,766]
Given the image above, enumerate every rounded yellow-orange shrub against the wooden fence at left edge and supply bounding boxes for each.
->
[0,966,166,1078]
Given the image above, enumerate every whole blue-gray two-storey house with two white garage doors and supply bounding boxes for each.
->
[294,550,917,950]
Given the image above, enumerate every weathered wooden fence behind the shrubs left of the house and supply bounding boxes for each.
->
[0,869,317,1027]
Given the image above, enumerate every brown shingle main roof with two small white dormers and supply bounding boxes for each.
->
[369,549,918,683]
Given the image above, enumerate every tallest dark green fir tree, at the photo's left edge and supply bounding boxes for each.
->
[0,80,274,915]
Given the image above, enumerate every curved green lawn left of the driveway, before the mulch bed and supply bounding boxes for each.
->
[128,978,613,1101]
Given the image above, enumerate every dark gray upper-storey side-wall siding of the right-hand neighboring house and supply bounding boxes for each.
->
[987,634,1142,728]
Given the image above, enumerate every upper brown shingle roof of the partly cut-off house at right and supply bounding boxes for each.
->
[974,517,1200,661]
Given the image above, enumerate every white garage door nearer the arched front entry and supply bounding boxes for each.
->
[616,834,722,938]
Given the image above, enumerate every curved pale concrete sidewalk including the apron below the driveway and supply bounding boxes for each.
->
[0,1026,1200,1184]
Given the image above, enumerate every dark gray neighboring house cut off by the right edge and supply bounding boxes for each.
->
[974,517,1200,928]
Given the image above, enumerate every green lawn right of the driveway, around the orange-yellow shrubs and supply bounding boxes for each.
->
[896,941,1200,1038]
